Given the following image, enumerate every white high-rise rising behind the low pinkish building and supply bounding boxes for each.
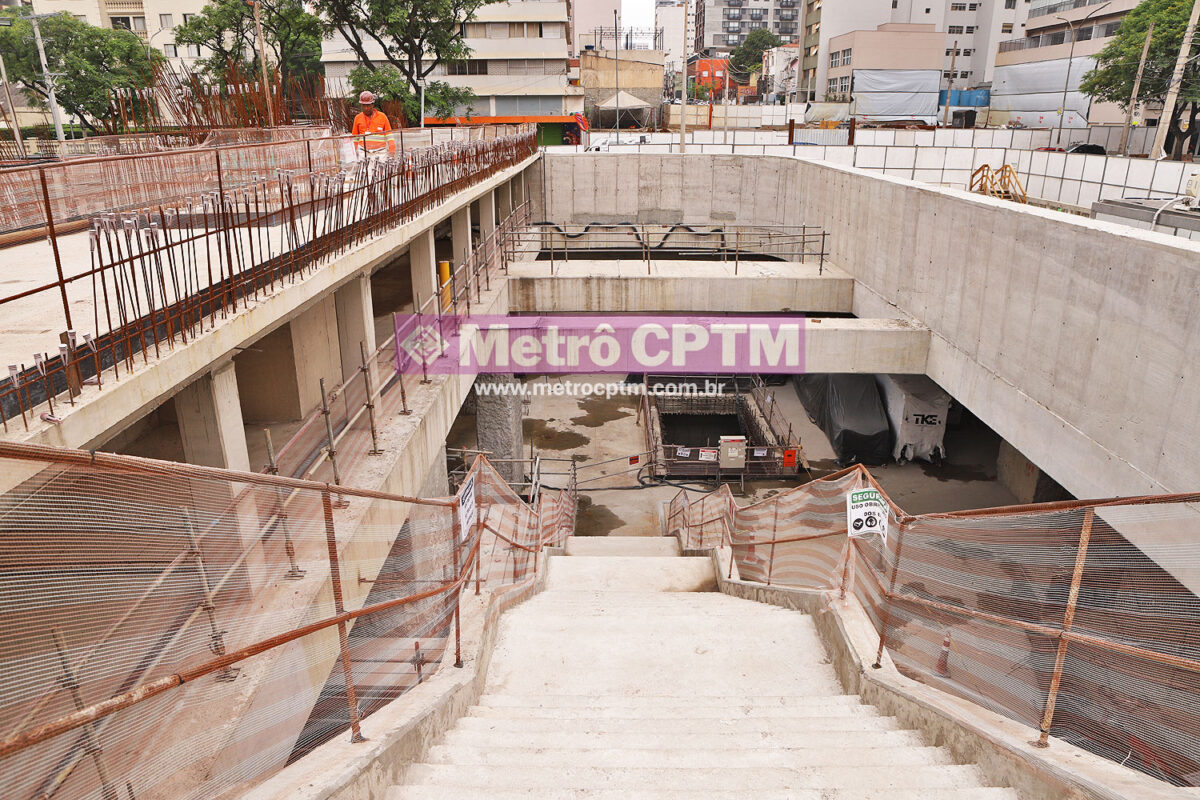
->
[800,0,1027,100]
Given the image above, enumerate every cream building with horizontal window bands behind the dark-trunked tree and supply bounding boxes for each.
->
[320,0,583,122]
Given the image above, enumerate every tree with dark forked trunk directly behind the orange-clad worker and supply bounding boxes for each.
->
[313,0,498,94]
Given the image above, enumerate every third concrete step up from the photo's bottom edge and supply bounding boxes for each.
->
[425,734,954,769]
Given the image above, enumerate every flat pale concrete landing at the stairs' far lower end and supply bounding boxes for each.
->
[546,555,716,591]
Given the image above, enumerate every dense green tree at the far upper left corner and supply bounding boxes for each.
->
[0,10,162,132]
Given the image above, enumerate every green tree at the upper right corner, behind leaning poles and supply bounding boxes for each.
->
[1080,0,1200,158]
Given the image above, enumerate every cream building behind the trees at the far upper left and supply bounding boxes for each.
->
[32,0,209,67]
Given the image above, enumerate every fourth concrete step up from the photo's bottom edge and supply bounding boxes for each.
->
[443,727,925,757]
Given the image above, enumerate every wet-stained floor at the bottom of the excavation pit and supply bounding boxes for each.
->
[448,375,1016,536]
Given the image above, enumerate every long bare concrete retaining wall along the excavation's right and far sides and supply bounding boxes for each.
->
[535,154,1200,497]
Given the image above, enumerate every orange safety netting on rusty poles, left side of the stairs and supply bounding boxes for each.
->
[0,444,574,800]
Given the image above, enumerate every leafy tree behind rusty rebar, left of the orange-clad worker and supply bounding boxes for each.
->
[175,0,323,86]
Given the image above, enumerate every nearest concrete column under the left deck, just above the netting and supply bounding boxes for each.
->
[175,361,250,471]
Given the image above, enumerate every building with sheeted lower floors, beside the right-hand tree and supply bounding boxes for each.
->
[990,0,1140,128]
